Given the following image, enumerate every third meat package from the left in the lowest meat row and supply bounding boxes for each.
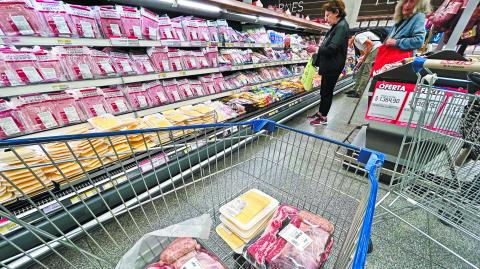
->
[46,92,86,126]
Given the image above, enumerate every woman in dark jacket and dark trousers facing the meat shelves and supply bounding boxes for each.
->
[309,0,349,125]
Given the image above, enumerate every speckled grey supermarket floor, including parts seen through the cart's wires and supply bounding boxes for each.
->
[31,89,480,269]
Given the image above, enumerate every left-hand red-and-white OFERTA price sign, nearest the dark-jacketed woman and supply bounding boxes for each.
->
[366,81,415,123]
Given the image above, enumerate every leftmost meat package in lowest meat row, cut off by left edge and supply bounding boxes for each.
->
[0,99,27,139]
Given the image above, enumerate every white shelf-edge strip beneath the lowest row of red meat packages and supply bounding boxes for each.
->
[12,75,300,139]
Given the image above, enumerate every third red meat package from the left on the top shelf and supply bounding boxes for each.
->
[65,4,102,38]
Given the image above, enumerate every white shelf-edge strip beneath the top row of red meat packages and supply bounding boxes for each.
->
[0,36,283,48]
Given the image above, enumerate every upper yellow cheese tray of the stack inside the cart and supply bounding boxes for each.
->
[219,189,279,231]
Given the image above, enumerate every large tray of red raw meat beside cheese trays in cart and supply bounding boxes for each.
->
[245,205,334,269]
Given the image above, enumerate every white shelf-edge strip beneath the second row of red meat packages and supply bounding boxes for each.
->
[0,60,308,97]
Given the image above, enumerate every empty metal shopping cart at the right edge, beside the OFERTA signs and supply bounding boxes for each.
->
[376,58,480,268]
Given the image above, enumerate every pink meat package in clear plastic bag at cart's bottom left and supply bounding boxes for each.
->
[146,237,227,269]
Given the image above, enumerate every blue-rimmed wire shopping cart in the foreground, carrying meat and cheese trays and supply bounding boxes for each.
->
[0,120,383,268]
